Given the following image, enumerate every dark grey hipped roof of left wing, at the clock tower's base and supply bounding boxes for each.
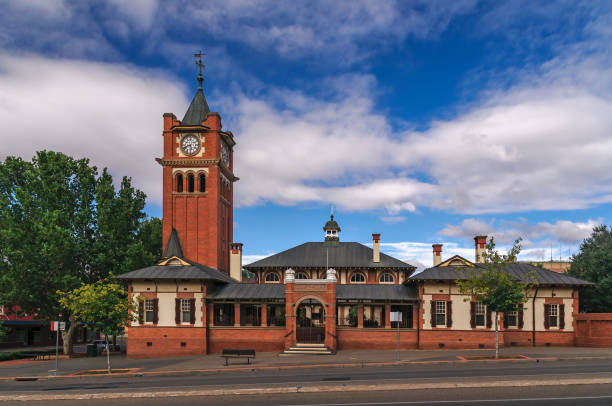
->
[116,259,234,283]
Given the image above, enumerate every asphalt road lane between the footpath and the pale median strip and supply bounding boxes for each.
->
[0,360,612,394]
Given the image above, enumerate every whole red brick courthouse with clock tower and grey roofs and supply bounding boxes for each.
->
[118,74,596,357]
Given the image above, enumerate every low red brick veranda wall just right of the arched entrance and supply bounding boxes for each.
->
[336,328,416,350]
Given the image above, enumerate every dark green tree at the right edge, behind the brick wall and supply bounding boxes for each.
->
[568,225,612,313]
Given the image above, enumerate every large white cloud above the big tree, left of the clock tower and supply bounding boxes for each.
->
[0,55,186,204]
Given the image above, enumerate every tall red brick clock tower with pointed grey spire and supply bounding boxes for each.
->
[157,60,238,273]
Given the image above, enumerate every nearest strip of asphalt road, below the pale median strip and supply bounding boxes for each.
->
[3,385,612,406]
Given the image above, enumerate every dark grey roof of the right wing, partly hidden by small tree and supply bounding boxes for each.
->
[410,263,594,286]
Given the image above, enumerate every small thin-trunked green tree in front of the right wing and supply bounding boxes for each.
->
[457,237,529,358]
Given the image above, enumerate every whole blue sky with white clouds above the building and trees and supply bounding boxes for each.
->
[0,0,612,266]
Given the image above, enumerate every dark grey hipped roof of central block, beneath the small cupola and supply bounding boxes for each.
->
[244,242,415,271]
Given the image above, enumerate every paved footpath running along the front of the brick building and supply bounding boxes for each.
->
[0,347,612,379]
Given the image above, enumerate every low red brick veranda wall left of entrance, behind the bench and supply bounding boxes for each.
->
[209,327,285,353]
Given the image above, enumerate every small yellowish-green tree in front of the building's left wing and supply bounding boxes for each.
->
[57,278,137,374]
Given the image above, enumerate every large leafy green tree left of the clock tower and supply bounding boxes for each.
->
[0,151,152,354]
